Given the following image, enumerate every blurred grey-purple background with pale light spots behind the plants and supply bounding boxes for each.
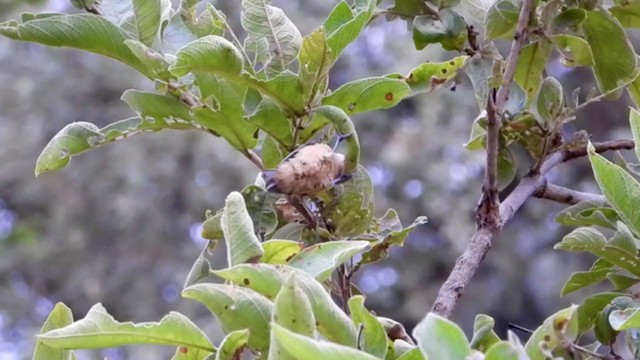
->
[0,0,630,360]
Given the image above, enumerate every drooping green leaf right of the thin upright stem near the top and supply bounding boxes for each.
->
[513,40,551,104]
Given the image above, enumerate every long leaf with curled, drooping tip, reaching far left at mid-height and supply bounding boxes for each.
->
[35,117,195,176]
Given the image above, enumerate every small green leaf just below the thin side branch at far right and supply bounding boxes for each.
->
[555,201,618,229]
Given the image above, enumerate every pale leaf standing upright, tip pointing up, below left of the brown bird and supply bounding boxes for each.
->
[221,191,264,266]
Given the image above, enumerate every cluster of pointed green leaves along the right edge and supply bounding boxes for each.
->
[555,109,640,357]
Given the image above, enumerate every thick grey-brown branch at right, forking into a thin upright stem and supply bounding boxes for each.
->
[432,0,544,317]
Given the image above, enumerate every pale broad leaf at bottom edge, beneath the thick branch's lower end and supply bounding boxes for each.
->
[413,312,471,360]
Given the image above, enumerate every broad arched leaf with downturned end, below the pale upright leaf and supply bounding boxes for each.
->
[182,283,273,351]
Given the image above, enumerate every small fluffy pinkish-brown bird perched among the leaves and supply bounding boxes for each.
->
[262,144,350,196]
